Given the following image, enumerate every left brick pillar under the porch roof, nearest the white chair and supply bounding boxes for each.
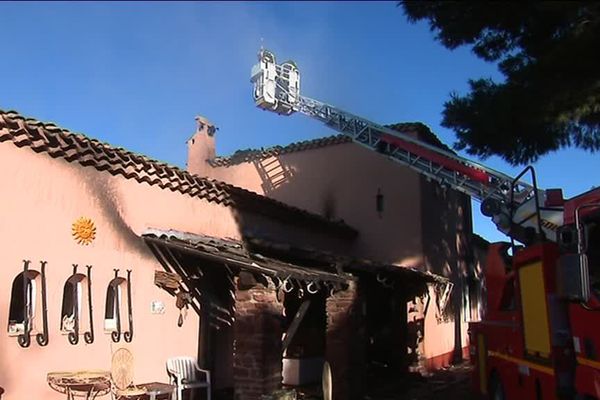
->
[233,282,283,400]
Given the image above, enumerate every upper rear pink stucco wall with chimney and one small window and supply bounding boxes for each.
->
[188,133,422,266]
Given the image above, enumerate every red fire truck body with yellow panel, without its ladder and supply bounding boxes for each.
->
[469,188,600,400]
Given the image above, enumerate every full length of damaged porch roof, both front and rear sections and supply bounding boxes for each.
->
[142,229,450,296]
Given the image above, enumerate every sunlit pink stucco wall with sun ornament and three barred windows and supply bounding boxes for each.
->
[0,142,239,400]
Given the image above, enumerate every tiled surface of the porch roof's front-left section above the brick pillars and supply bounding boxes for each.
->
[142,229,355,285]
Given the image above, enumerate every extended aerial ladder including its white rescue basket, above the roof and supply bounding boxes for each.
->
[251,49,563,243]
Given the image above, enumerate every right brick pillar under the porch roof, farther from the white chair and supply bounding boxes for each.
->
[326,282,366,400]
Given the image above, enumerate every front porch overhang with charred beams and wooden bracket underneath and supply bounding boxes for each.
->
[141,229,356,368]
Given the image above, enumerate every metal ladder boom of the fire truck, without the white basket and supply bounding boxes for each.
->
[293,96,562,241]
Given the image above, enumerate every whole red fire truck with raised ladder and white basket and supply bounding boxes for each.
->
[251,49,600,400]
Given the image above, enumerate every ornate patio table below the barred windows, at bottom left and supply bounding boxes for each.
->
[47,371,110,400]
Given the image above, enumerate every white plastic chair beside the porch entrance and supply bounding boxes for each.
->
[167,356,210,400]
